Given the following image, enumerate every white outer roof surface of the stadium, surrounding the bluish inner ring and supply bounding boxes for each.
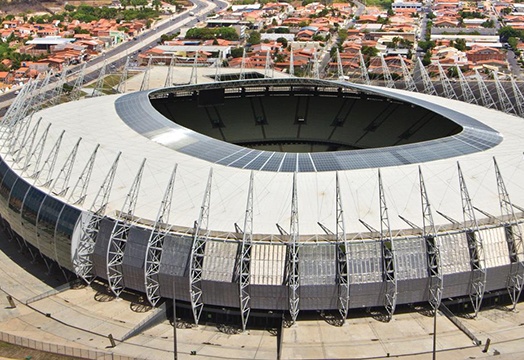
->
[24,82,524,239]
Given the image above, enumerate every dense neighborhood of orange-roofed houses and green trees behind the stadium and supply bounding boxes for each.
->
[0,0,524,88]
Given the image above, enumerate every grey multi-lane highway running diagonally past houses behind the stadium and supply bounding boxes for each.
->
[0,0,229,117]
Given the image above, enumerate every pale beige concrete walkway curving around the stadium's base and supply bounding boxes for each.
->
[0,229,524,360]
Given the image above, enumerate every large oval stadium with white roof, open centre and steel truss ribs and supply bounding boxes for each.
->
[0,78,524,352]
